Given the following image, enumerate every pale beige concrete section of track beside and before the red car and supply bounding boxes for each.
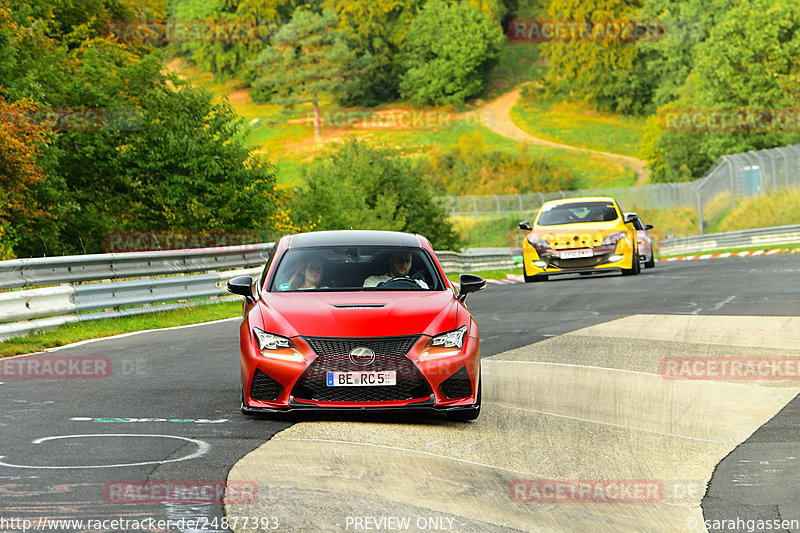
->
[226,315,800,532]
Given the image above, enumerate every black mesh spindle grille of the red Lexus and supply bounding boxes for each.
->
[292,335,432,402]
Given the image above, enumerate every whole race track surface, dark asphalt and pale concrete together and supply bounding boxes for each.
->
[0,255,800,532]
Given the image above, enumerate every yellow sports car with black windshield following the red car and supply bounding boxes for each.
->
[519,197,641,282]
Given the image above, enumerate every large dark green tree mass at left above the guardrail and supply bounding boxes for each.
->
[0,0,277,256]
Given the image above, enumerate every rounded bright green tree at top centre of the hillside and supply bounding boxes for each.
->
[400,0,505,105]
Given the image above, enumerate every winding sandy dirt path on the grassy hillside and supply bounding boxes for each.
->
[480,87,650,185]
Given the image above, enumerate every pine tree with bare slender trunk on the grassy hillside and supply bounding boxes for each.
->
[248,9,354,138]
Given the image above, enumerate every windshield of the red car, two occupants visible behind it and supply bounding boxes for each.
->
[269,246,445,292]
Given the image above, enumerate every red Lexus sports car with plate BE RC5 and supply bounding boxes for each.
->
[228,230,486,420]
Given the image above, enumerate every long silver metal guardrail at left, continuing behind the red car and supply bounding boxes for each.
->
[0,243,514,340]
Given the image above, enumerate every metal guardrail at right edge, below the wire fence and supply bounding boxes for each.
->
[659,225,800,255]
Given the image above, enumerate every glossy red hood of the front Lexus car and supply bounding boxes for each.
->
[255,290,459,337]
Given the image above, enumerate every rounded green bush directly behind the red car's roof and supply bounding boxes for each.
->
[292,139,460,250]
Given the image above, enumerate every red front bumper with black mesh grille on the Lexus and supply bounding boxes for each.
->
[242,335,480,413]
